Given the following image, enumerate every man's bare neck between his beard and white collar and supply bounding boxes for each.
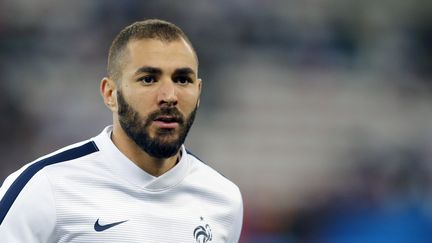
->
[111,124,180,177]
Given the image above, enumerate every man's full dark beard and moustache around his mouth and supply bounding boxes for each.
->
[117,91,198,159]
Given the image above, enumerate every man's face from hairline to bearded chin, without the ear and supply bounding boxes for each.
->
[117,39,201,158]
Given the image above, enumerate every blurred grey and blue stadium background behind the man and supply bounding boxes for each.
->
[0,0,432,243]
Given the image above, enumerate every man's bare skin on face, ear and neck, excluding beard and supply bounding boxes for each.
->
[100,39,202,176]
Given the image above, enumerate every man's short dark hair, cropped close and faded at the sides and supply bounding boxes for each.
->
[107,19,198,83]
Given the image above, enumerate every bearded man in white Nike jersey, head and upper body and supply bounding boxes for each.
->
[0,20,243,243]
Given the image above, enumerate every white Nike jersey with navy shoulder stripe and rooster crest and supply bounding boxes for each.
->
[0,127,243,243]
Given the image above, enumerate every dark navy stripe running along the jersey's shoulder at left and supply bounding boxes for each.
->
[0,141,99,225]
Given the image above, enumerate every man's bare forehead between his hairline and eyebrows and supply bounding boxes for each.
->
[125,39,198,71]
